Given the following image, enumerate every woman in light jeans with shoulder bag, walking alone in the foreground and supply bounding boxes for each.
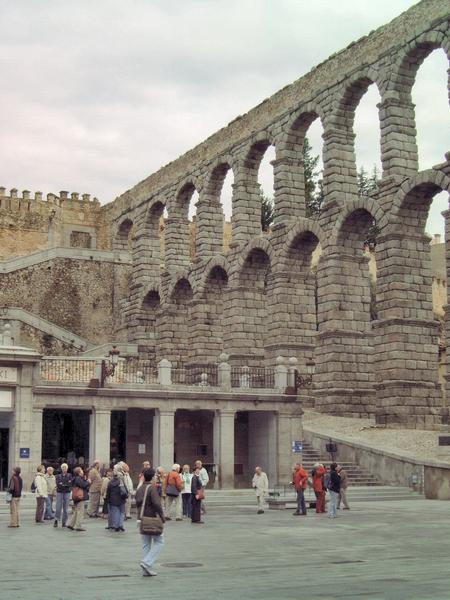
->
[136,469,165,577]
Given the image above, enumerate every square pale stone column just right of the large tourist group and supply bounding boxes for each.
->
[214,410,235,488]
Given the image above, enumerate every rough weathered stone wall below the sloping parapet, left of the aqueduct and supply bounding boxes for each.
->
[0,258,130,354]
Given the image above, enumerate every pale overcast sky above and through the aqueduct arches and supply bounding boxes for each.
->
[0,0,449,232]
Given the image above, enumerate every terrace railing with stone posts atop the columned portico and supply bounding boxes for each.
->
[40,354,306,393]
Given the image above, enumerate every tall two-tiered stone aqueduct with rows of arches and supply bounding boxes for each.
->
[108,0,450,428]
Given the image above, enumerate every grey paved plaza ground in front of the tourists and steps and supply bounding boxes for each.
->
[0,500,450,600]
